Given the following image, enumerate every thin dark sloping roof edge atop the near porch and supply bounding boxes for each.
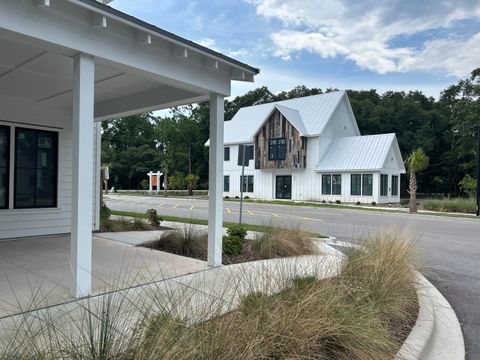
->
[76,0,260,74]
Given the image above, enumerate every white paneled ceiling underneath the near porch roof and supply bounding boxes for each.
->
[0,31,208,120]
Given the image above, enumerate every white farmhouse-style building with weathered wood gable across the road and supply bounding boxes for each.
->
[207,91,405,203]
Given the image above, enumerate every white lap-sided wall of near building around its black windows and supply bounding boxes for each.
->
[0,98,101,239]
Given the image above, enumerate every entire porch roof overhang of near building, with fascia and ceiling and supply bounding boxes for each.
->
[0,0,259,121]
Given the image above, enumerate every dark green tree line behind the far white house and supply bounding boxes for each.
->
[102,68,480,195]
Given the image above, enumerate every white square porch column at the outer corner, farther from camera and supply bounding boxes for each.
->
[208,94,224,266]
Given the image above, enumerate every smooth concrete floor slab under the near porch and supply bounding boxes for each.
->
[0,234,207,318]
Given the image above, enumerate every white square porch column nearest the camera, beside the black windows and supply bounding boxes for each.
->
[70,54,95,298]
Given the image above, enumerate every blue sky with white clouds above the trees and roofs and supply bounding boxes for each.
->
[110,0,480,98]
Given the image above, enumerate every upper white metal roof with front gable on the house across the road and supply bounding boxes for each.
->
[219,91,346,144]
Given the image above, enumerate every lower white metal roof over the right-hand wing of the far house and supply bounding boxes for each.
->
[315,134,405,172]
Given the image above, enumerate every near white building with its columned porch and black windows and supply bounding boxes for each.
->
[0,0,259,297]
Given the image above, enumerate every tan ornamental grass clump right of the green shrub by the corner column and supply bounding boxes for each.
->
[250,226,318,259]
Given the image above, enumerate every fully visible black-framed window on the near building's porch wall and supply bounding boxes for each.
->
[14,128,58,209]
